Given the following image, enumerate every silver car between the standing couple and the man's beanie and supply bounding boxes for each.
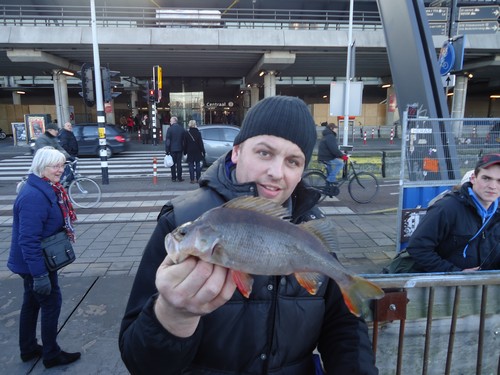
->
[198,124,240,165]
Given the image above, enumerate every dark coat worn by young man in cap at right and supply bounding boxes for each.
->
[407,182,500,272]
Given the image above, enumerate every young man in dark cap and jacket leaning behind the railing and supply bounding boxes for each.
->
[406,154,500,272]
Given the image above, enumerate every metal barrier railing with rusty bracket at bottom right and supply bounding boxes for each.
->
[365,271,500,375]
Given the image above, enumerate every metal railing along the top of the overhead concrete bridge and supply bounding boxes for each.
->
[0,5,382,30]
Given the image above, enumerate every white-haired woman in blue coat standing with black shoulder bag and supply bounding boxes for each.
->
[7,147,80,368]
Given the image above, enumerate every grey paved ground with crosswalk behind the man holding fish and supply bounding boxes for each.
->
[0,172,396,375]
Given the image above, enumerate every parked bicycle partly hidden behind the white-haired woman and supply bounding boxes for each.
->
[16,160,102,208]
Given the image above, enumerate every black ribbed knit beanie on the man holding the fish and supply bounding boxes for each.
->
[234,96,316,166]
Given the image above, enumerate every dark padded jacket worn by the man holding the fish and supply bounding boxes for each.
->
[119,153,378,375]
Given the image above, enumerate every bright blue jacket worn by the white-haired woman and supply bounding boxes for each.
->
[7,173,64,277]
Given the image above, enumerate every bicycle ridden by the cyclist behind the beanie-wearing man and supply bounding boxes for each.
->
[302,154,379,204]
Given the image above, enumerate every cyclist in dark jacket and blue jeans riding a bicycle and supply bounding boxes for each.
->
[318,123,345,182]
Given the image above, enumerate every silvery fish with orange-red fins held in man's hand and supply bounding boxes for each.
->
[165,196,384,316]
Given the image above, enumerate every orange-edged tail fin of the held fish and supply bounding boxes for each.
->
[339,275,384,316]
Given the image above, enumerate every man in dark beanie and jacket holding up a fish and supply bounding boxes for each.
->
[119,96,378,375]
